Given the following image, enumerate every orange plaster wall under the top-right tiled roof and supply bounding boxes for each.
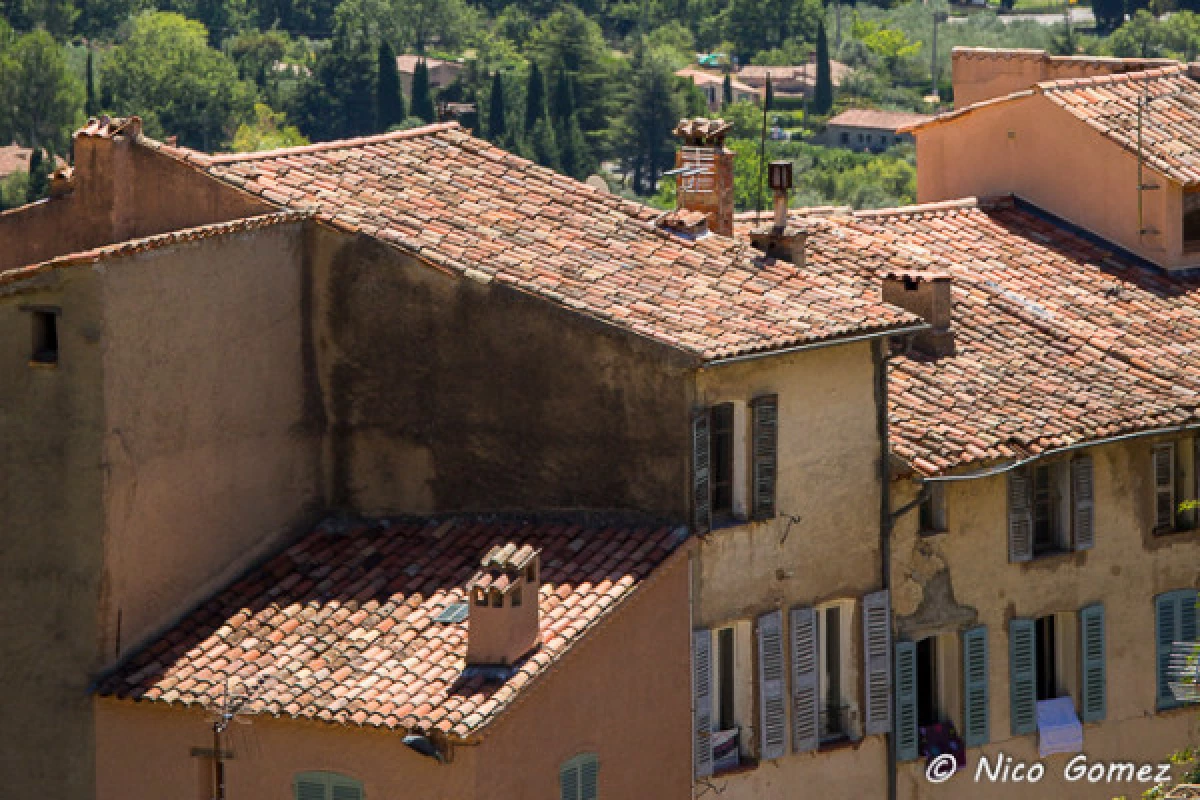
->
[917,95,1185,267]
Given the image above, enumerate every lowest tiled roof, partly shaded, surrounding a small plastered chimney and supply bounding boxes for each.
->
[96,518,688,738]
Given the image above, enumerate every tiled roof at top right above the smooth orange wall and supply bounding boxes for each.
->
[1038,65,1200,186]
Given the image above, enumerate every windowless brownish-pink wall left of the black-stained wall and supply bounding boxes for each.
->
[95,224,322,663]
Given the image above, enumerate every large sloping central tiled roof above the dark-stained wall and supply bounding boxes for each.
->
[164,124,919,359]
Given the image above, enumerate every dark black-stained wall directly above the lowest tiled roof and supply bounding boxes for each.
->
[310,229,690,519]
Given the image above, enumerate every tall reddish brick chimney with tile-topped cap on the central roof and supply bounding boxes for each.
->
[674,118,733,236]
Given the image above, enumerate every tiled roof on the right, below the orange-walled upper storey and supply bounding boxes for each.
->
[816,200,1200,475]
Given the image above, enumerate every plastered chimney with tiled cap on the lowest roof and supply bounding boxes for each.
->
[467,542,541,666]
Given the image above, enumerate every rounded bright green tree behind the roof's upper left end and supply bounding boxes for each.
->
[101,12,254,150]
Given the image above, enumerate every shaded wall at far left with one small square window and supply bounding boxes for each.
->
[0,271,104,800]
